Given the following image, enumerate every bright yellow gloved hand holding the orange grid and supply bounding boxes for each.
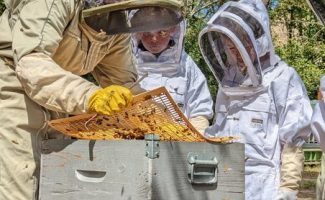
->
[88,85,133,115]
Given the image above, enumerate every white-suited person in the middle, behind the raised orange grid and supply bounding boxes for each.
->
[132,21,213,133]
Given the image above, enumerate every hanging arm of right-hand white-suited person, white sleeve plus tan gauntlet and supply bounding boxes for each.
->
[275,68,312,199]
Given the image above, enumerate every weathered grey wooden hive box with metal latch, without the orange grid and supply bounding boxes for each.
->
[39,138,244,200]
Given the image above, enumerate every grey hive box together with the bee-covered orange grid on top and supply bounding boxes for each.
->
[40,88,244,200]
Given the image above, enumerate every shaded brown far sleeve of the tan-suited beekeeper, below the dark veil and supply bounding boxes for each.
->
[92,34,142,94]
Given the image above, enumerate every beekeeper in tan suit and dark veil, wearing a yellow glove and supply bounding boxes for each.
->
[0,0,182,200]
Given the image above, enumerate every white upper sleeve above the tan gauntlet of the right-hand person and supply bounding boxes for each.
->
[273,68,313,146]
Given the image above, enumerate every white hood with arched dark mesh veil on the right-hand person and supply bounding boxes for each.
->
[199,0,278,96]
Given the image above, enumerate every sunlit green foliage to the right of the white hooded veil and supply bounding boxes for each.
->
[270,0,325,99]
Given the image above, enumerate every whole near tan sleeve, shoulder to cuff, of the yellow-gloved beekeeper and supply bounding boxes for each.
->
[12,0,102,114]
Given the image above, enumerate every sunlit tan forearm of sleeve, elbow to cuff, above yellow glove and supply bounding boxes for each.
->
[16,53,99,114]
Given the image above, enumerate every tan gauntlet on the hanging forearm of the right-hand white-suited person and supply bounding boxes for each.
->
[280,144,305,191]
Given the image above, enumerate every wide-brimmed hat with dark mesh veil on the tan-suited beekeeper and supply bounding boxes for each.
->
[81,0,182,34]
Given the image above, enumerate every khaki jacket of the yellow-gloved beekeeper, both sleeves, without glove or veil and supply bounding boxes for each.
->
[0,0,137,114]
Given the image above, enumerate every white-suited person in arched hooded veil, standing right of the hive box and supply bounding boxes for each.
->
[199,0,312,200]
